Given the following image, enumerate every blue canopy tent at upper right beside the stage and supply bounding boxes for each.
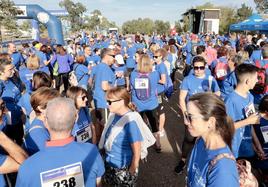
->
[230,14,264,31]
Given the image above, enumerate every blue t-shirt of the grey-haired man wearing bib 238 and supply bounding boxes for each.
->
[16,141,105,187]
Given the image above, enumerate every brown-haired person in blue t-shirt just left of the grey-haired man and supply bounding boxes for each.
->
[24,87,60,155]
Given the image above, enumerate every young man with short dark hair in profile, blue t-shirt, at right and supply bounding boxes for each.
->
[225,64,259,158]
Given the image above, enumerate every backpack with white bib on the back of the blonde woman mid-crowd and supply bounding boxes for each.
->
[134,73,151,101]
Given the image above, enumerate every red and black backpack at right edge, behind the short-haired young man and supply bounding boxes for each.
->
[252,60,268,94]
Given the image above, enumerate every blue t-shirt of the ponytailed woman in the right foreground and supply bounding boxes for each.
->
[187,138,239,187]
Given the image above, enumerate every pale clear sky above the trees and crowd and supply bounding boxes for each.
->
[13,0,255,26]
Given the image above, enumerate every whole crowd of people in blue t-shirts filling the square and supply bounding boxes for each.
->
[0,30,268,187]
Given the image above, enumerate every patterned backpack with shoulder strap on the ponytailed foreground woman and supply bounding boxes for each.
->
[208,153,258,187]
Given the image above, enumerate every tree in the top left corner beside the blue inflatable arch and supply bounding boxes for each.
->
[0,0,22,42]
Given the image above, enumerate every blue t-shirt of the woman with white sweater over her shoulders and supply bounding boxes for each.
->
[105,115,143,168]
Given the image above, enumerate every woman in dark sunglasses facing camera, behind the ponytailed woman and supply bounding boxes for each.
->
[175,56,220,174]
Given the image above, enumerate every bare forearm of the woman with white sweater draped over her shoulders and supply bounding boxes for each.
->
[129,142,141,175]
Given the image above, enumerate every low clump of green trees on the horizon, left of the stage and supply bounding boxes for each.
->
[122,18,170,34]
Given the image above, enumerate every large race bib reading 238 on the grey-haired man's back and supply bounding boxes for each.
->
[40,162,85,187]
